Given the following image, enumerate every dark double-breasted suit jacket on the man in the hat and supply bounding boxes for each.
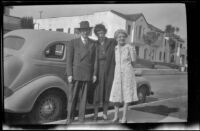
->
[66,38,98,81]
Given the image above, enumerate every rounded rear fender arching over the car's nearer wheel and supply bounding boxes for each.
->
[4,75,68,113]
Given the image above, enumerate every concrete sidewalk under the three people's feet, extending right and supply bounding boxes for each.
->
[46,96,187,124]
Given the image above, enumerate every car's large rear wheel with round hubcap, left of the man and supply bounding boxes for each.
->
[29,92,66,124]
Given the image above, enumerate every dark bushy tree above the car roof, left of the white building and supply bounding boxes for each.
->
[21,17,34,29]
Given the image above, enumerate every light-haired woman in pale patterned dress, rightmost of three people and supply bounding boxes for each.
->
[109,29,138,123]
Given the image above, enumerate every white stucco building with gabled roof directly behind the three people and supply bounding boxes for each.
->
[34,10,186,65]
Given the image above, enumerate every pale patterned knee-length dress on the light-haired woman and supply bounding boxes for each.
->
[109,44,138,103]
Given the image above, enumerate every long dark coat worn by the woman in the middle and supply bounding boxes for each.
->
[91,38,117,103]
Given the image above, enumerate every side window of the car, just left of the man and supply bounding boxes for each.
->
[44,42,65,59]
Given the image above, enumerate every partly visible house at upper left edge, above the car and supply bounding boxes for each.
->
[3,6,21,33]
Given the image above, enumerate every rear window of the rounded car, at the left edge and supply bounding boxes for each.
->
[4,36,25,50]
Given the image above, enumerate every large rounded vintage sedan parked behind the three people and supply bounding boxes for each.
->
[4,29,152,123]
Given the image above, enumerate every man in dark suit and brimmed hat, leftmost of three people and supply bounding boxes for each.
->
[66,21,98,123]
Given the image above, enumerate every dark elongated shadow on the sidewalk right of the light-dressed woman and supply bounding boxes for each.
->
[131,105,179,116]
